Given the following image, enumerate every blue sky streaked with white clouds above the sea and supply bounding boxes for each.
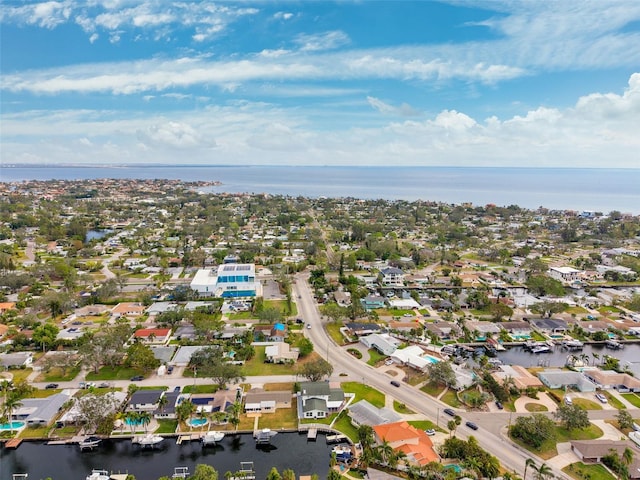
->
[0,0,640,168]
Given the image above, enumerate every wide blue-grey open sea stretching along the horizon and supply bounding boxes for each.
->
[0,165,640,214]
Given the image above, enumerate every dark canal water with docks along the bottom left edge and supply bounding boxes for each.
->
[0,433,338,480]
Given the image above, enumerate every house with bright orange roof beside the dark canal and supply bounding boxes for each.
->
[373,421,440,466]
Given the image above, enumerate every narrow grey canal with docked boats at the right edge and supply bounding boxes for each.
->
[497,343,640,368]
